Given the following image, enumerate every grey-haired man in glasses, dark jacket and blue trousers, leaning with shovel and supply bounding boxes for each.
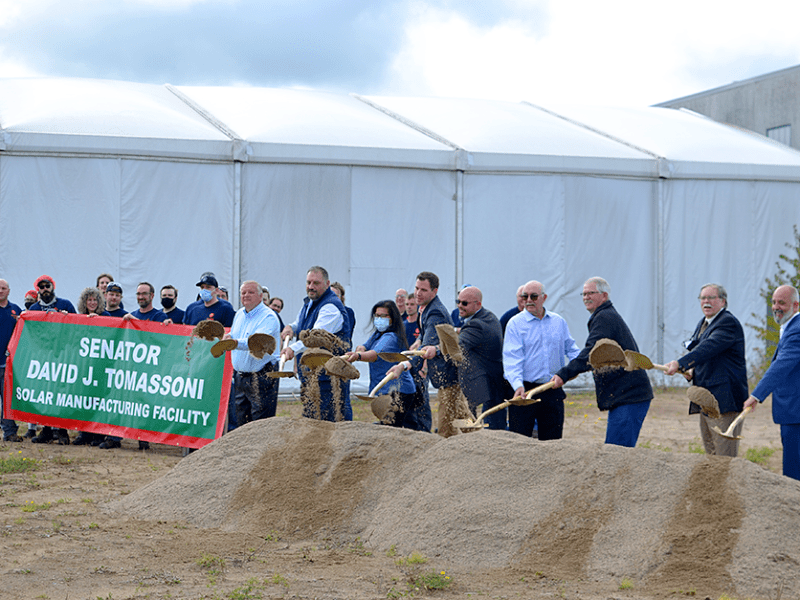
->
[553,277,653,448]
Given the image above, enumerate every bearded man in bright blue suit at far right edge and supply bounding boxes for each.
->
[744,285,800,480]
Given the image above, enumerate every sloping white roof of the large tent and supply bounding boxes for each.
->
[0,78,800,181]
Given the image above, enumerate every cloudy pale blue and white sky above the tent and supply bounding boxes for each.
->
[0,0,800,106]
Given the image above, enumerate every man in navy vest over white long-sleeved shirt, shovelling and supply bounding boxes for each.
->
[281,266,353,421]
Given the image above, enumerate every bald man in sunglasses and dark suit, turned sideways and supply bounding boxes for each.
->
[458,286,507,429]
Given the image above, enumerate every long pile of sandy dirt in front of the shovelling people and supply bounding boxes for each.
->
[109,417,800,597]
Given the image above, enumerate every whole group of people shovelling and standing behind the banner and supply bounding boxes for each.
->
[0,266,800,479]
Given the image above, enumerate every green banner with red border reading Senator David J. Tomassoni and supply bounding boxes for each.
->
[3,311,233,448]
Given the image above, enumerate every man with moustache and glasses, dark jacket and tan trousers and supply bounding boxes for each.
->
[666,283,747,456]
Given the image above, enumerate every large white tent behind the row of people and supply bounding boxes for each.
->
[0,79,800,376]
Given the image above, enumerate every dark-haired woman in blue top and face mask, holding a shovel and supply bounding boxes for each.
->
[343,300,416,427]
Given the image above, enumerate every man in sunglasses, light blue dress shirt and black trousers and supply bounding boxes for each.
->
[503,281,580,440]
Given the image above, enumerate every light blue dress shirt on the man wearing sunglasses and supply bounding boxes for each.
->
[503,310,580,390]
